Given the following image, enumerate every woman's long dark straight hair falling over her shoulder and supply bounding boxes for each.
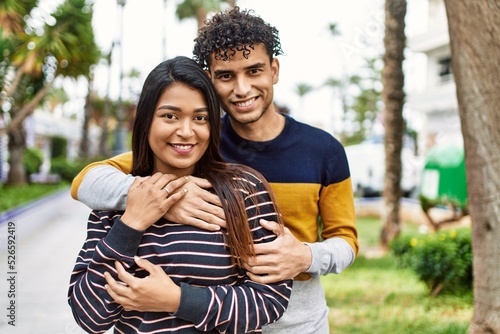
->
[132,56,282,266]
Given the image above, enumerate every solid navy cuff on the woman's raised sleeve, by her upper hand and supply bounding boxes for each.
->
[104,219,144,257]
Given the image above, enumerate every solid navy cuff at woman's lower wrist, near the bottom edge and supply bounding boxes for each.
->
[174,282,212,326]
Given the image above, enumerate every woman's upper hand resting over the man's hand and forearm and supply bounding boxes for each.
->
[121,173,189,231]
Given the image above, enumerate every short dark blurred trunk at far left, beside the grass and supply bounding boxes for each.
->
[7,127,28,186]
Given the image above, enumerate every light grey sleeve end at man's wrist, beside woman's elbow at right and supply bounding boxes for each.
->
[306,237,355,276]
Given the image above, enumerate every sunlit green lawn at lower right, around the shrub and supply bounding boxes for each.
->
[322,219,473,334]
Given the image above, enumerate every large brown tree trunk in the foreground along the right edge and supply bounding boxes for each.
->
[445,0,500,333]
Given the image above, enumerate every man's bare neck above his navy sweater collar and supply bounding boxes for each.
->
[229,110,285,141]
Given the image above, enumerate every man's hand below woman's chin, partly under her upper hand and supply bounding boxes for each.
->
[164,176,226,231]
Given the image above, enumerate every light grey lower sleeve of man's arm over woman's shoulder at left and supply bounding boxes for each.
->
[78,166,134,210]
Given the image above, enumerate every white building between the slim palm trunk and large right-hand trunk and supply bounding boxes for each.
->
[407,0,463,153]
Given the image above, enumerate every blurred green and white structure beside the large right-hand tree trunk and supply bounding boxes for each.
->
[420,146,467,205]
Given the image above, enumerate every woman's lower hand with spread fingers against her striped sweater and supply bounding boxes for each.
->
[104,256,181,312]
